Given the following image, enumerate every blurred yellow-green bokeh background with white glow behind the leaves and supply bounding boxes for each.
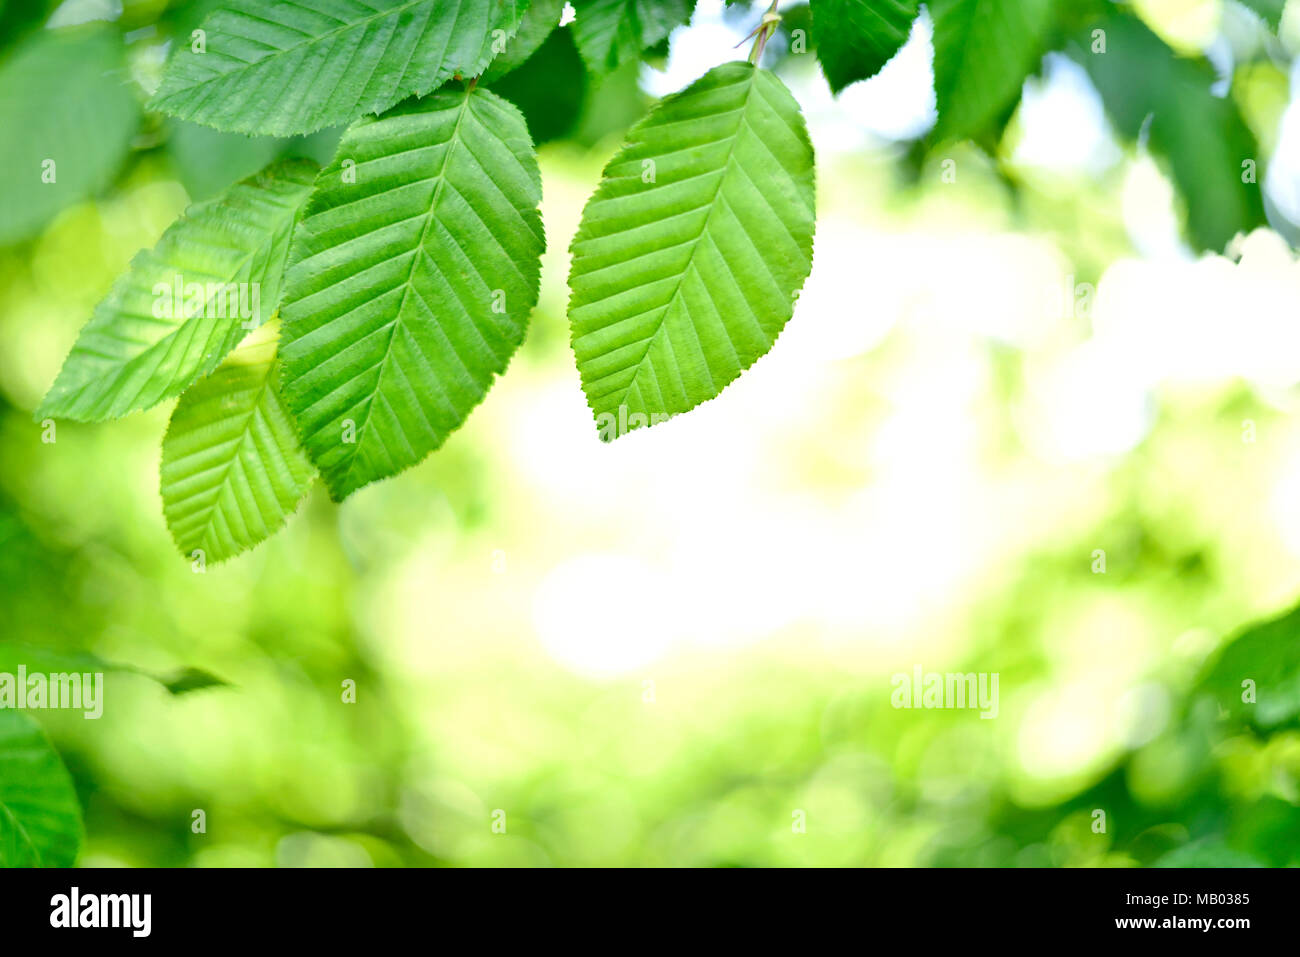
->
[0,0,1300,866]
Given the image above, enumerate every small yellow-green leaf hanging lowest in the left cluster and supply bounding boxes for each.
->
[161,320,315,563]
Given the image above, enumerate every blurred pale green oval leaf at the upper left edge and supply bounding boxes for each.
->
[0,25,140,243]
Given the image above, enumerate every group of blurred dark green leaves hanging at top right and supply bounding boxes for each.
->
[811,0,1284,252]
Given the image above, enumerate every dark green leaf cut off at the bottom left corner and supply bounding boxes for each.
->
[0,709,82,867]
